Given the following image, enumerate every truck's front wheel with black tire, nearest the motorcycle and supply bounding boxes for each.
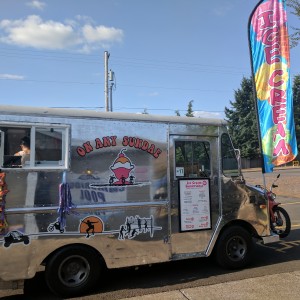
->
[215,226,254,269]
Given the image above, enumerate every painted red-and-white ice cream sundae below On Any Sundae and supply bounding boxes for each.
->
[109,149,134,185]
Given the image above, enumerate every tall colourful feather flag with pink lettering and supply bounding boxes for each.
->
[248,0,297,173]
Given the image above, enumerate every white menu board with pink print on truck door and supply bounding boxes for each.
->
[179,178,211,231]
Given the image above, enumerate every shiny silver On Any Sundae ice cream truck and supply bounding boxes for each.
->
[0,106,278,297]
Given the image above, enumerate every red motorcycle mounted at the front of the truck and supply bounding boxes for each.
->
[257,174,291,238]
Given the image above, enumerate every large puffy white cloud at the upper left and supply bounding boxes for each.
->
[0,15,124,52]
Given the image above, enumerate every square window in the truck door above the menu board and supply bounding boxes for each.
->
[175,141,211,178]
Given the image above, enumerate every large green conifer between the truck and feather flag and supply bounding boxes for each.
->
[225,77,260,158]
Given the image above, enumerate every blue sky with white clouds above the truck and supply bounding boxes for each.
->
[0,0,300,119]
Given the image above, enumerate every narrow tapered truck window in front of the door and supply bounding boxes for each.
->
[221,134,240,177]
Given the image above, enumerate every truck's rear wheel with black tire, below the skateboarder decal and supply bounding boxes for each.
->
[45,245,104,297]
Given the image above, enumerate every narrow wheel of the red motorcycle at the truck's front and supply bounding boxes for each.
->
[271,206,291,238]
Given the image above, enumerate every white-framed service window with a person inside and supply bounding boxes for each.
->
[0,124,70,169]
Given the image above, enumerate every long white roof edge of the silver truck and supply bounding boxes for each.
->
[0,105,227,126]
